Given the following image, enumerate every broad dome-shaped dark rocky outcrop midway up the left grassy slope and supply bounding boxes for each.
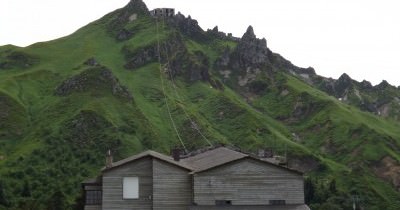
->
[55,66,133,101]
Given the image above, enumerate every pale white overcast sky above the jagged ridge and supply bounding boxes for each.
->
[0,0,400,86]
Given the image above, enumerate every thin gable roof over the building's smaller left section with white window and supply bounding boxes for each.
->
[102,150,193,171]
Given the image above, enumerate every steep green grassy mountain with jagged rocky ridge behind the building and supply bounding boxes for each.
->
[0,0,400,209]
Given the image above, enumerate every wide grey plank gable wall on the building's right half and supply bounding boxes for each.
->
[194,159,304,205]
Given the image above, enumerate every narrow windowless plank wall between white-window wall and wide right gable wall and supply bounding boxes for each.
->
[153,159,192,210]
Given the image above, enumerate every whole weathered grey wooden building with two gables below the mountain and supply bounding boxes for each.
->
[82,147,309,210]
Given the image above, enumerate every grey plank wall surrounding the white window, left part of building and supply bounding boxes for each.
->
[102,157,153,210]
